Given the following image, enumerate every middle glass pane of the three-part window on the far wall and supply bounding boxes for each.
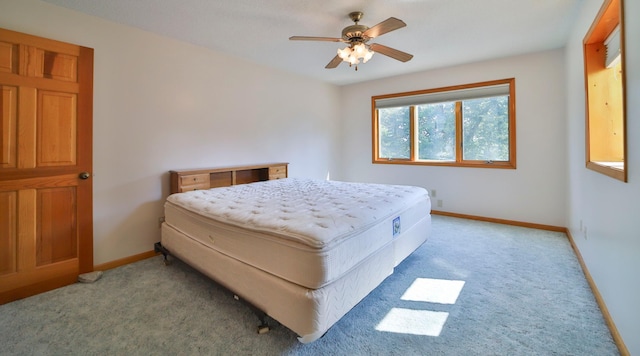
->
[416,102,456,161]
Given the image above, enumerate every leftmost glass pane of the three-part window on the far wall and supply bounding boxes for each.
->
[378,106,411,159]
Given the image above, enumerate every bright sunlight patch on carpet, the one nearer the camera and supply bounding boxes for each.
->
[376,308,449,336]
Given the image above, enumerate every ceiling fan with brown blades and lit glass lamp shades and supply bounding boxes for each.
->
[289,11,413,70]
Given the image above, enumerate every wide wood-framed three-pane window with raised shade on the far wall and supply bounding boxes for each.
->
[371,78,516,168]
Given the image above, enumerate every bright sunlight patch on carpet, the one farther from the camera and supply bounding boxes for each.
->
[400,278,464,304]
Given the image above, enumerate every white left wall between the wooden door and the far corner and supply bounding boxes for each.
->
[0,0,339,264]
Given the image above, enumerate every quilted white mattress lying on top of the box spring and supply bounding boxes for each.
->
[163,178,431,289]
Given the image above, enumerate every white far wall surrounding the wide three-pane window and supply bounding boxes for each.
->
[340,50,567,226]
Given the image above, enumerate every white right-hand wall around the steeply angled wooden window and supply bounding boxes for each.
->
[566,0,640,355]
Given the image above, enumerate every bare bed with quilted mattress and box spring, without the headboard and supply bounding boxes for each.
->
[160,178,431,343]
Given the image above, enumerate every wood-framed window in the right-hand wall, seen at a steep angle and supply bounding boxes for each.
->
[583,0,627,182]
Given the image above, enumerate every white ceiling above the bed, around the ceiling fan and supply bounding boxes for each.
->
[38,0,582,85]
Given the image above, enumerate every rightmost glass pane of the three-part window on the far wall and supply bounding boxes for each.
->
[462,96,509,161]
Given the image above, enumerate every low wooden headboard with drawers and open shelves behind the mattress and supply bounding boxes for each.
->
[169,163,289,194]
